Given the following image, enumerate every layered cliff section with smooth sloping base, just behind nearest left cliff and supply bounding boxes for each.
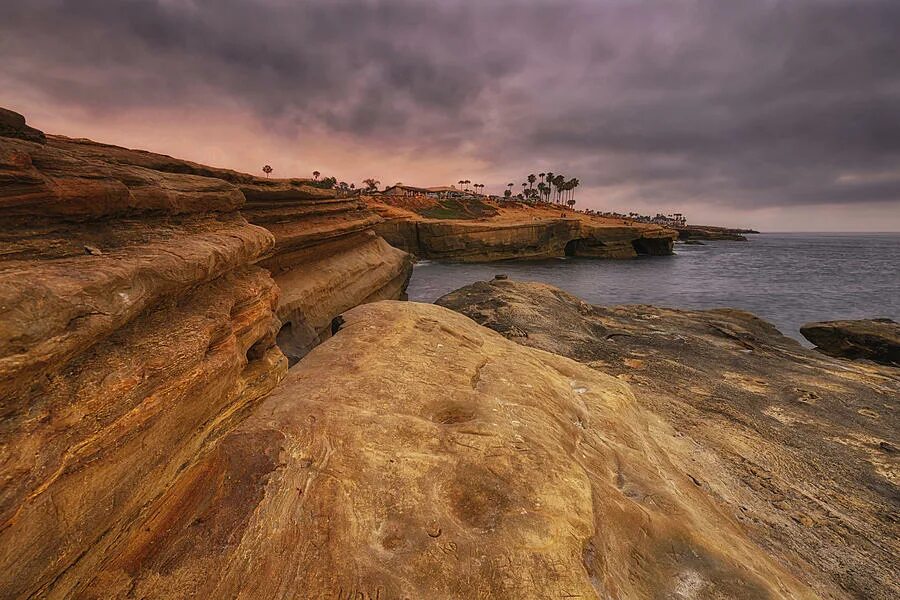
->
[241,180,412,364]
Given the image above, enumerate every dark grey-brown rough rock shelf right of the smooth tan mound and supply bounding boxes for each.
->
[438,280,900,600]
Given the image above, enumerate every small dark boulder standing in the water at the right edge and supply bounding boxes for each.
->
[800,319,900,366]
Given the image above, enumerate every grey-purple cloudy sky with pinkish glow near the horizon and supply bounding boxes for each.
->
[0,0,900,231]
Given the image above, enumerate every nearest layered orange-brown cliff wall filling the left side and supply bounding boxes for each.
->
[0,112,287,598]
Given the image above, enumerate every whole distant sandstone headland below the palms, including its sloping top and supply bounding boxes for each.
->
[367,198,678,262]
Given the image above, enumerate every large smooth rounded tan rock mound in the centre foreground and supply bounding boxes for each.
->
[70,302,816,600]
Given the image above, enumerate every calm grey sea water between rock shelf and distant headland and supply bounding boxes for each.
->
[409,233,900,345]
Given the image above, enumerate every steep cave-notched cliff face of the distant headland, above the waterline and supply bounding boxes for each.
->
[377,217,676,262]
